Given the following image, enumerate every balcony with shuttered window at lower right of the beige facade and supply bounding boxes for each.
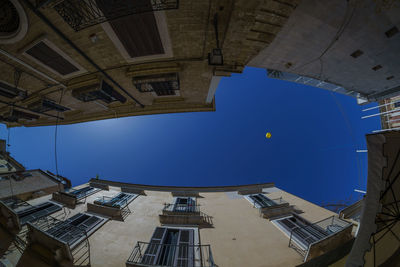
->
[289,216,353,261]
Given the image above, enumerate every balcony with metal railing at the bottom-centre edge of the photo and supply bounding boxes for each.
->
[126,242,217,267]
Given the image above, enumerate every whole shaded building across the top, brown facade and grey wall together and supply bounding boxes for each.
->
[0,0,400,126]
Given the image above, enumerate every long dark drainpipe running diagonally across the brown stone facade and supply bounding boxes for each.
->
[23,0,144,108]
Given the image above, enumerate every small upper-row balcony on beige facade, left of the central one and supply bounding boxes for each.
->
[87,192,135,221]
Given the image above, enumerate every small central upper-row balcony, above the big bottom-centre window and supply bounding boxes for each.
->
[159,204,213,227]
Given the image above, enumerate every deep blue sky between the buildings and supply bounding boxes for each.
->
[0,68,380,207]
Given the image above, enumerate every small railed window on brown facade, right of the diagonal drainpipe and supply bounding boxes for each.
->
[133,73,179,96]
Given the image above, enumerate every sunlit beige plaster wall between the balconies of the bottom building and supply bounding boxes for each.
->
[1,185,342,267]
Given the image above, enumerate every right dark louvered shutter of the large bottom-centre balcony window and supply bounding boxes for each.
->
[174,229,194,267]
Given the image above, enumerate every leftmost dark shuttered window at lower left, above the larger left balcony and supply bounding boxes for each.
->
[17,202,61,225]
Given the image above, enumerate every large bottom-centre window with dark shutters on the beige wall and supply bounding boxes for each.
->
[141,227,194,267]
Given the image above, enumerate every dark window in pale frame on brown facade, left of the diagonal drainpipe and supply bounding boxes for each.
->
[24,39,85,78]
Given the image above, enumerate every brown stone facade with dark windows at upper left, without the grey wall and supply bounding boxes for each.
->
[0,0,297,126]
